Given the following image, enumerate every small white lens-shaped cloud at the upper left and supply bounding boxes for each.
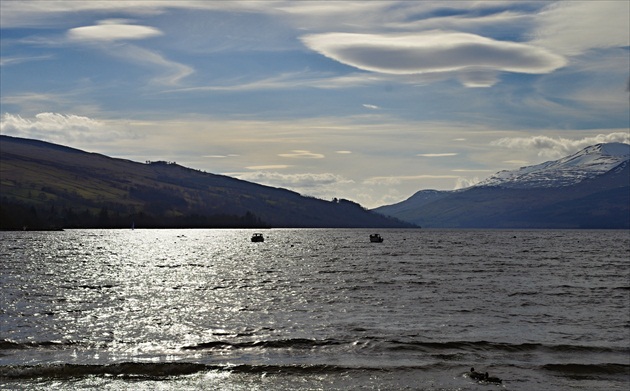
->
[68,19,162,42]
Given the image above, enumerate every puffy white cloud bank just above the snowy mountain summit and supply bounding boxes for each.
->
[490,132,630,158]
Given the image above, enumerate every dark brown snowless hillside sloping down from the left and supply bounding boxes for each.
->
[0,136,413,229]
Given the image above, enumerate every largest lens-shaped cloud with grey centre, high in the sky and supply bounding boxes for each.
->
[302,31,566,86]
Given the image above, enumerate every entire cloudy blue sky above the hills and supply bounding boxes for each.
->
[0,0,630,208]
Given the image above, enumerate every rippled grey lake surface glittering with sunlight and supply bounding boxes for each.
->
[0,229,630,391]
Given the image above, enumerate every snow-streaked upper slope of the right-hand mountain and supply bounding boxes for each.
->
[475,143,630,189]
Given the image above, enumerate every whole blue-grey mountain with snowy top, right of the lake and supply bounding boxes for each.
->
[374,143,630,229]
